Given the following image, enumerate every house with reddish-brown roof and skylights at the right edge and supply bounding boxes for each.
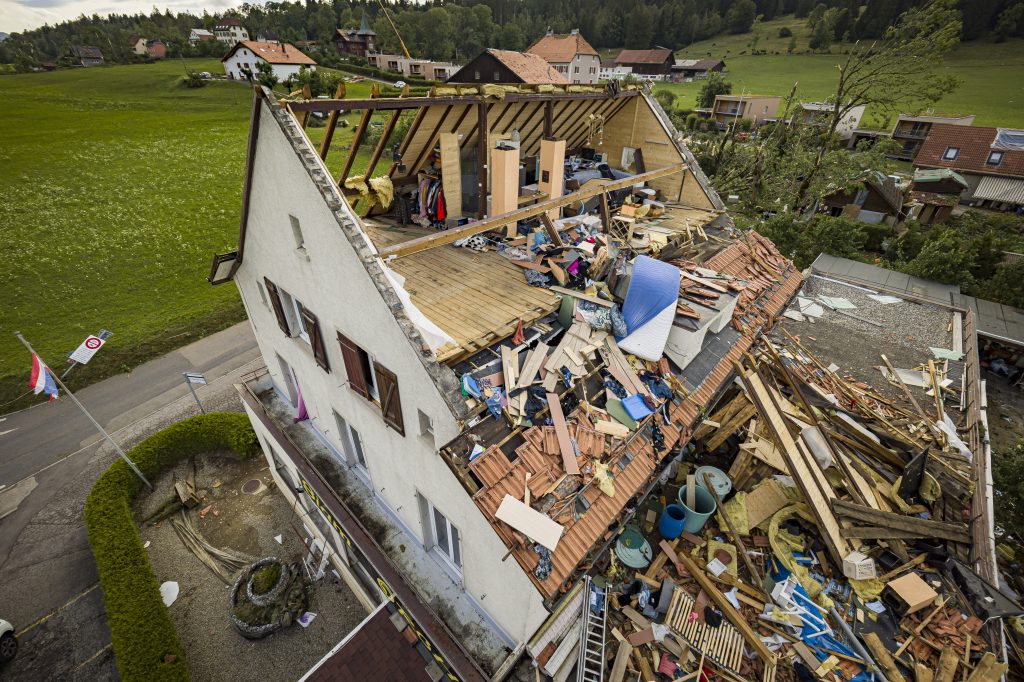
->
[913,123,1024,211]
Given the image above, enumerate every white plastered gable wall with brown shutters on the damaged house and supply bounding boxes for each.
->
[236,99,547,641]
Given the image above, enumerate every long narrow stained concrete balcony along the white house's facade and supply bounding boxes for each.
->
[240,375,508,671]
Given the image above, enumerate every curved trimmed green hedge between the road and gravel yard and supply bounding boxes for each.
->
[84,413,258,682]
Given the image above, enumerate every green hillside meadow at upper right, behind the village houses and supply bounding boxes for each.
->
[656,17,1024,128]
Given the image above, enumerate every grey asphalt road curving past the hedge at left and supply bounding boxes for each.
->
[0,323,259,680]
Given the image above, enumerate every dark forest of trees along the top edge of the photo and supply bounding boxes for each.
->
[0,0,1024,71]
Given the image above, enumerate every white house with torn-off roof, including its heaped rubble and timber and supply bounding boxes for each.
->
[210,78,1012,681]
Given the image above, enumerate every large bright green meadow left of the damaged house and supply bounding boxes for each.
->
[0,60,380,403]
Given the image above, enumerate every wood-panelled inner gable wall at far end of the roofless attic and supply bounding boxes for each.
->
[597,96,688,202]
